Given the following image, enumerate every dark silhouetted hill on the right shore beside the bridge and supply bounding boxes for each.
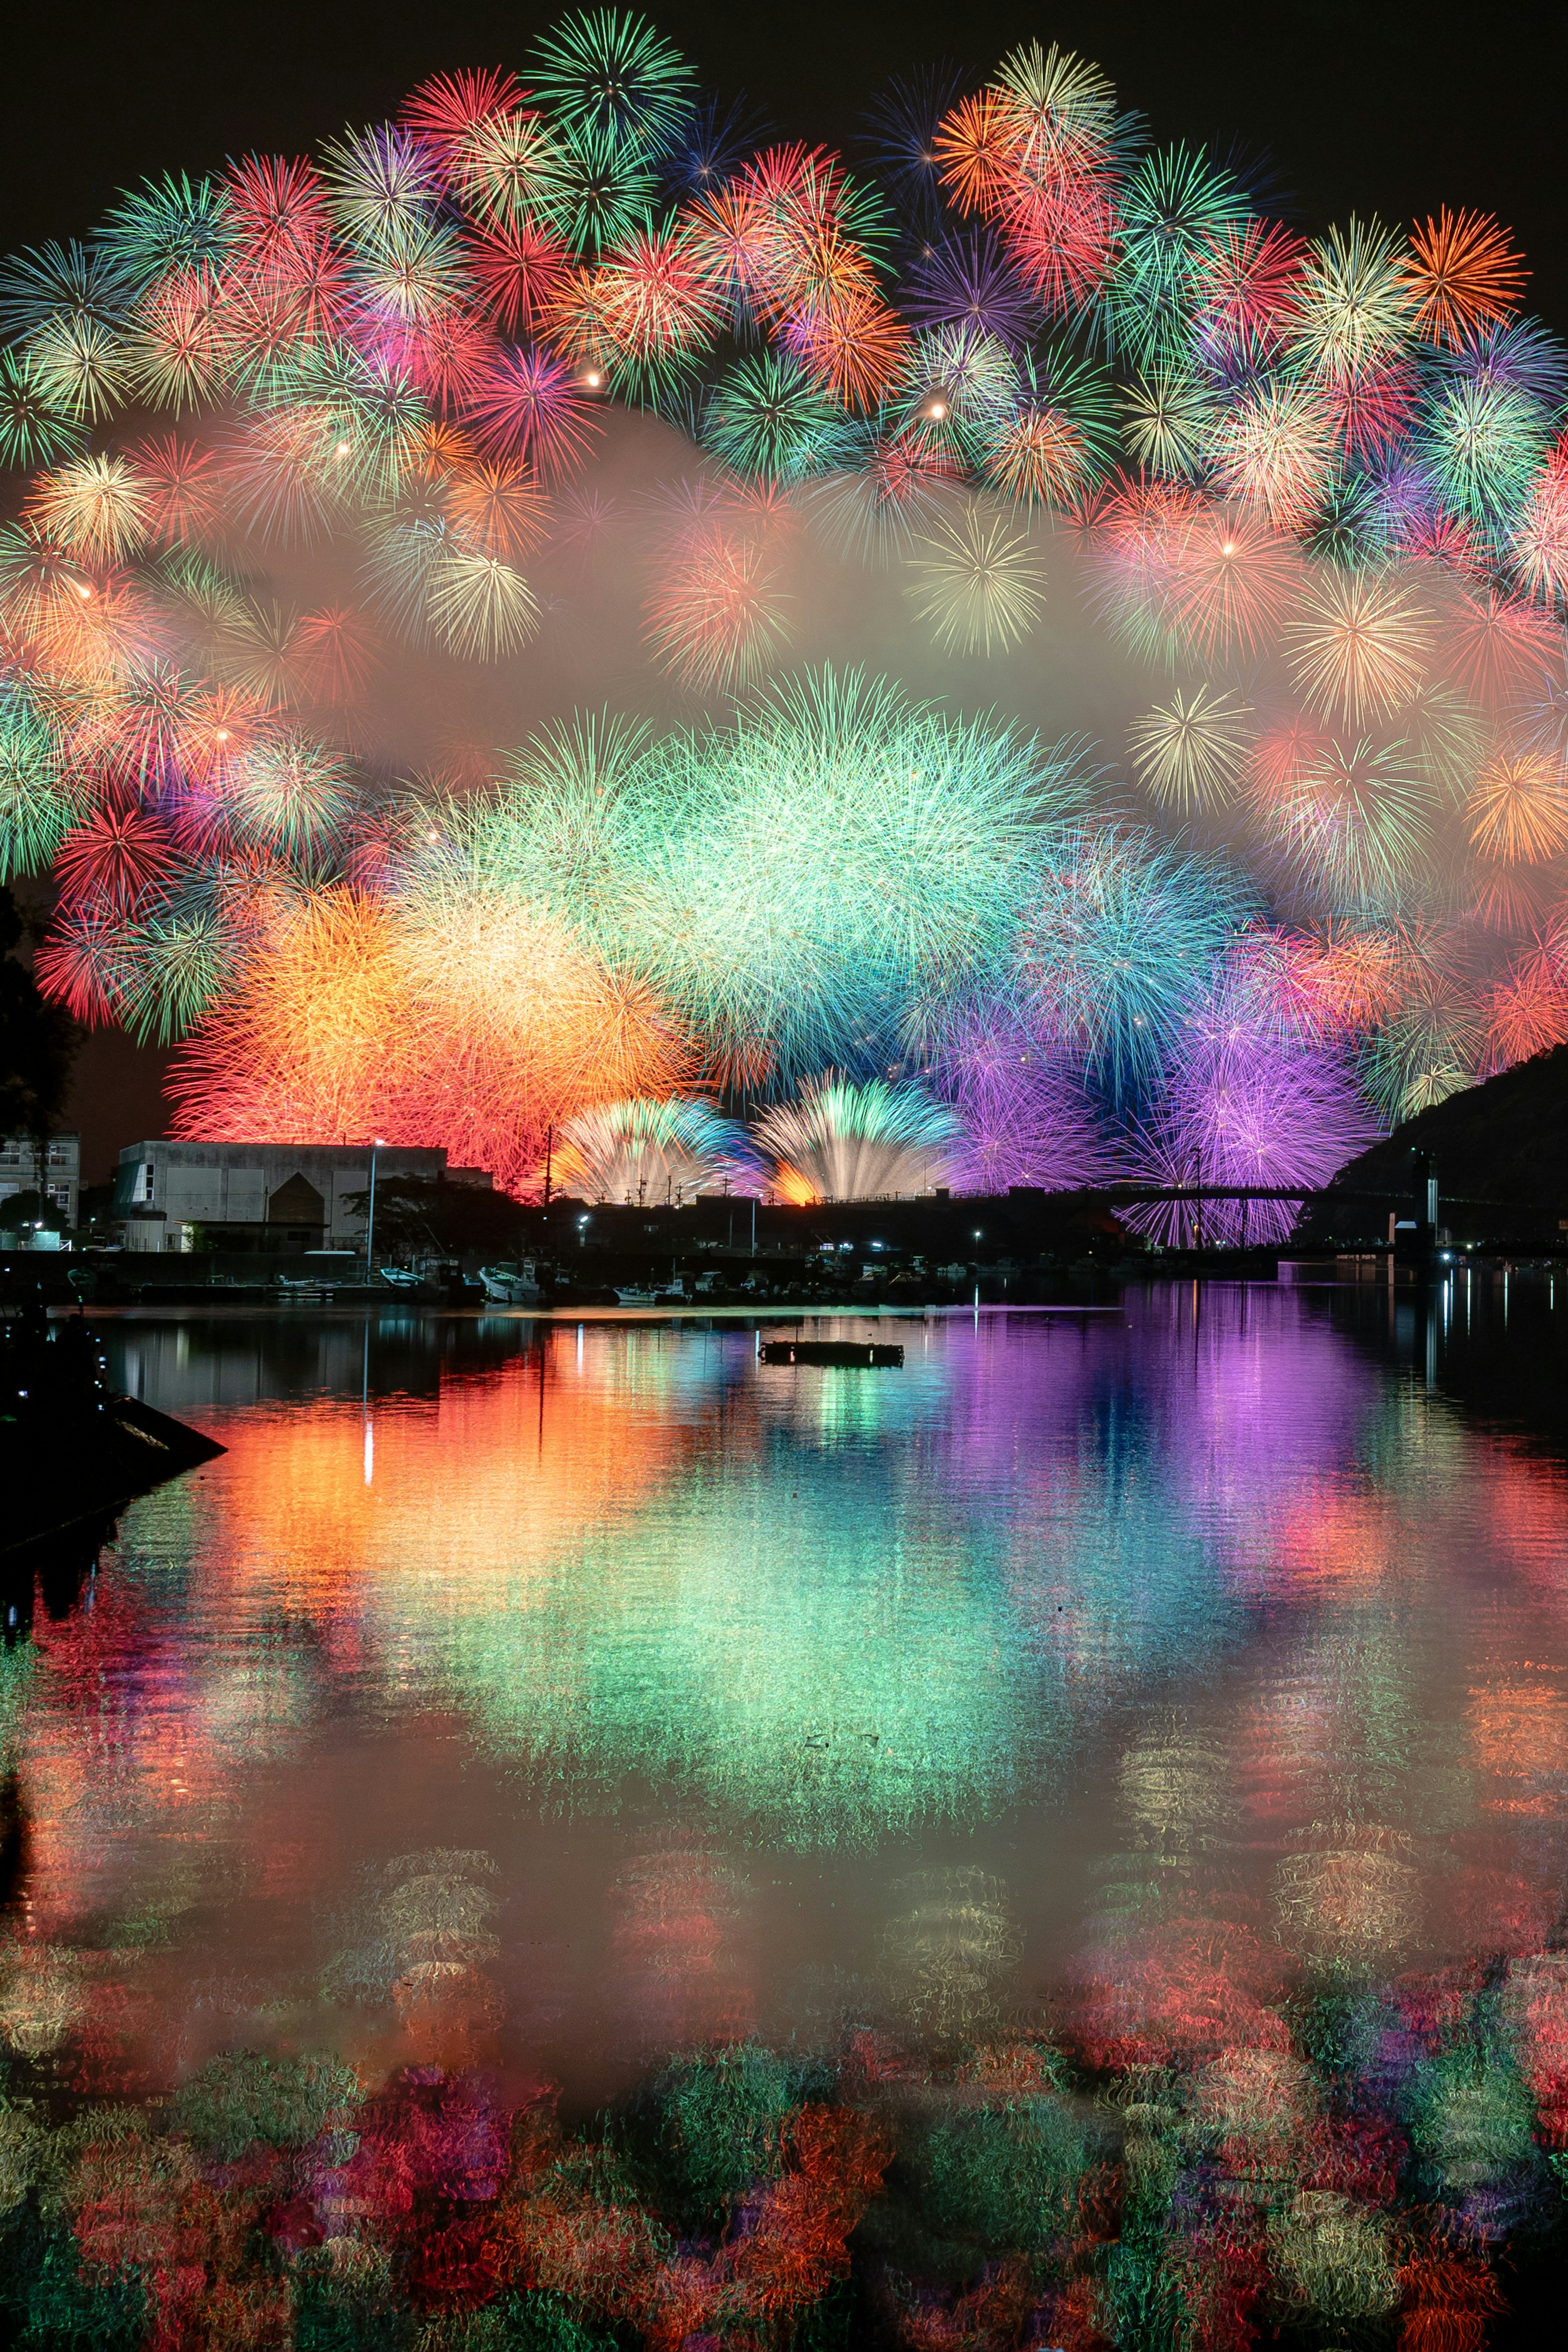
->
[1302,1044,1568,1244]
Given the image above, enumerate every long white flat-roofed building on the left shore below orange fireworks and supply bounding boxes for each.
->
[113,1143,446,1254]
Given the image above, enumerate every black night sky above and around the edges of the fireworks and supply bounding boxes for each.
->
[0,0,1568,1174]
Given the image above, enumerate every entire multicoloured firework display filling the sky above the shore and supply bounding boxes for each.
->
[0,9,1568,1193]
